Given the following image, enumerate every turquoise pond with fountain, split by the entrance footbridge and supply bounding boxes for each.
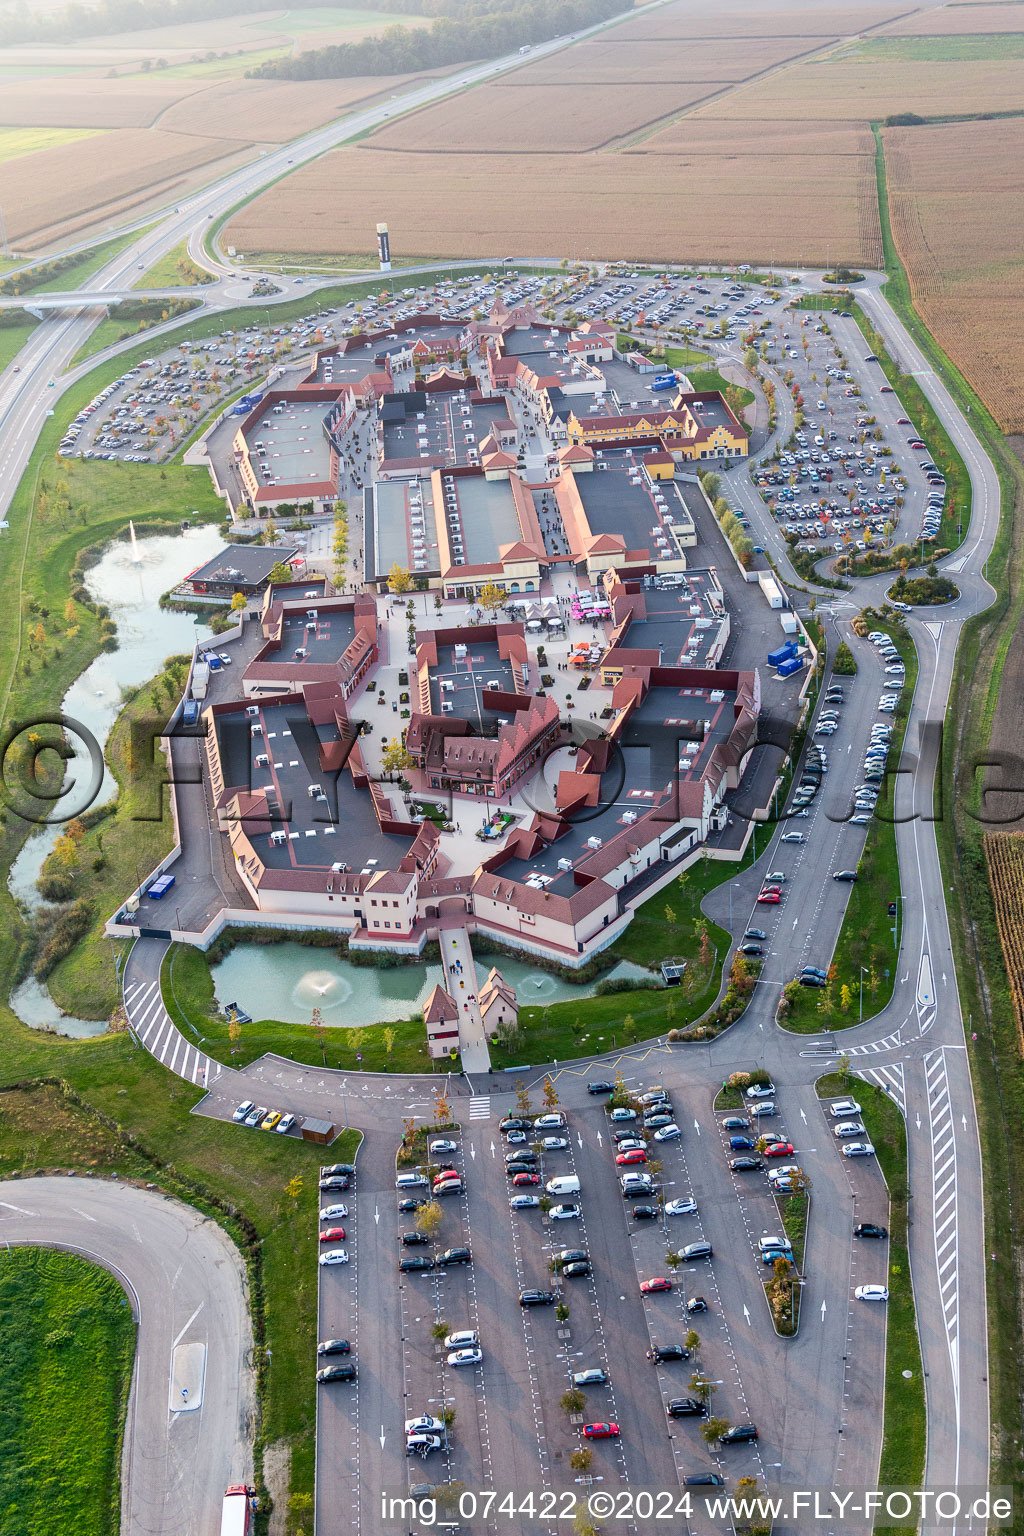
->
[213,943,649,1029]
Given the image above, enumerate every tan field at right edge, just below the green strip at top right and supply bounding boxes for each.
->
[714,43,1024,121]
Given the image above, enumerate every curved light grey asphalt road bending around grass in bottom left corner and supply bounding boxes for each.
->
[0,1178,255,1536]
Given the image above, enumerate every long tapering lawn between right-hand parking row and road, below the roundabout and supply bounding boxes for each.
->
[780,622,918,1034]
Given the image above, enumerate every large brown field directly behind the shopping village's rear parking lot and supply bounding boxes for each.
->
[223,140,880,266]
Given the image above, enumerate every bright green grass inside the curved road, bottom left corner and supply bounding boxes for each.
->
[0,1247,135,1536]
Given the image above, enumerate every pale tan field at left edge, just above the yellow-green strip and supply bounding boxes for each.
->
[0,78,197,127]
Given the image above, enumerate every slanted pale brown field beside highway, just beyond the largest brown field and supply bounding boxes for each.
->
[366,81,722,152]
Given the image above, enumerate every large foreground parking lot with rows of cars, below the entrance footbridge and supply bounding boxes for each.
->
[300,1050,887,1533]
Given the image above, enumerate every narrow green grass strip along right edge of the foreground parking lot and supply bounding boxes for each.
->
[817,1072,927,1536]
